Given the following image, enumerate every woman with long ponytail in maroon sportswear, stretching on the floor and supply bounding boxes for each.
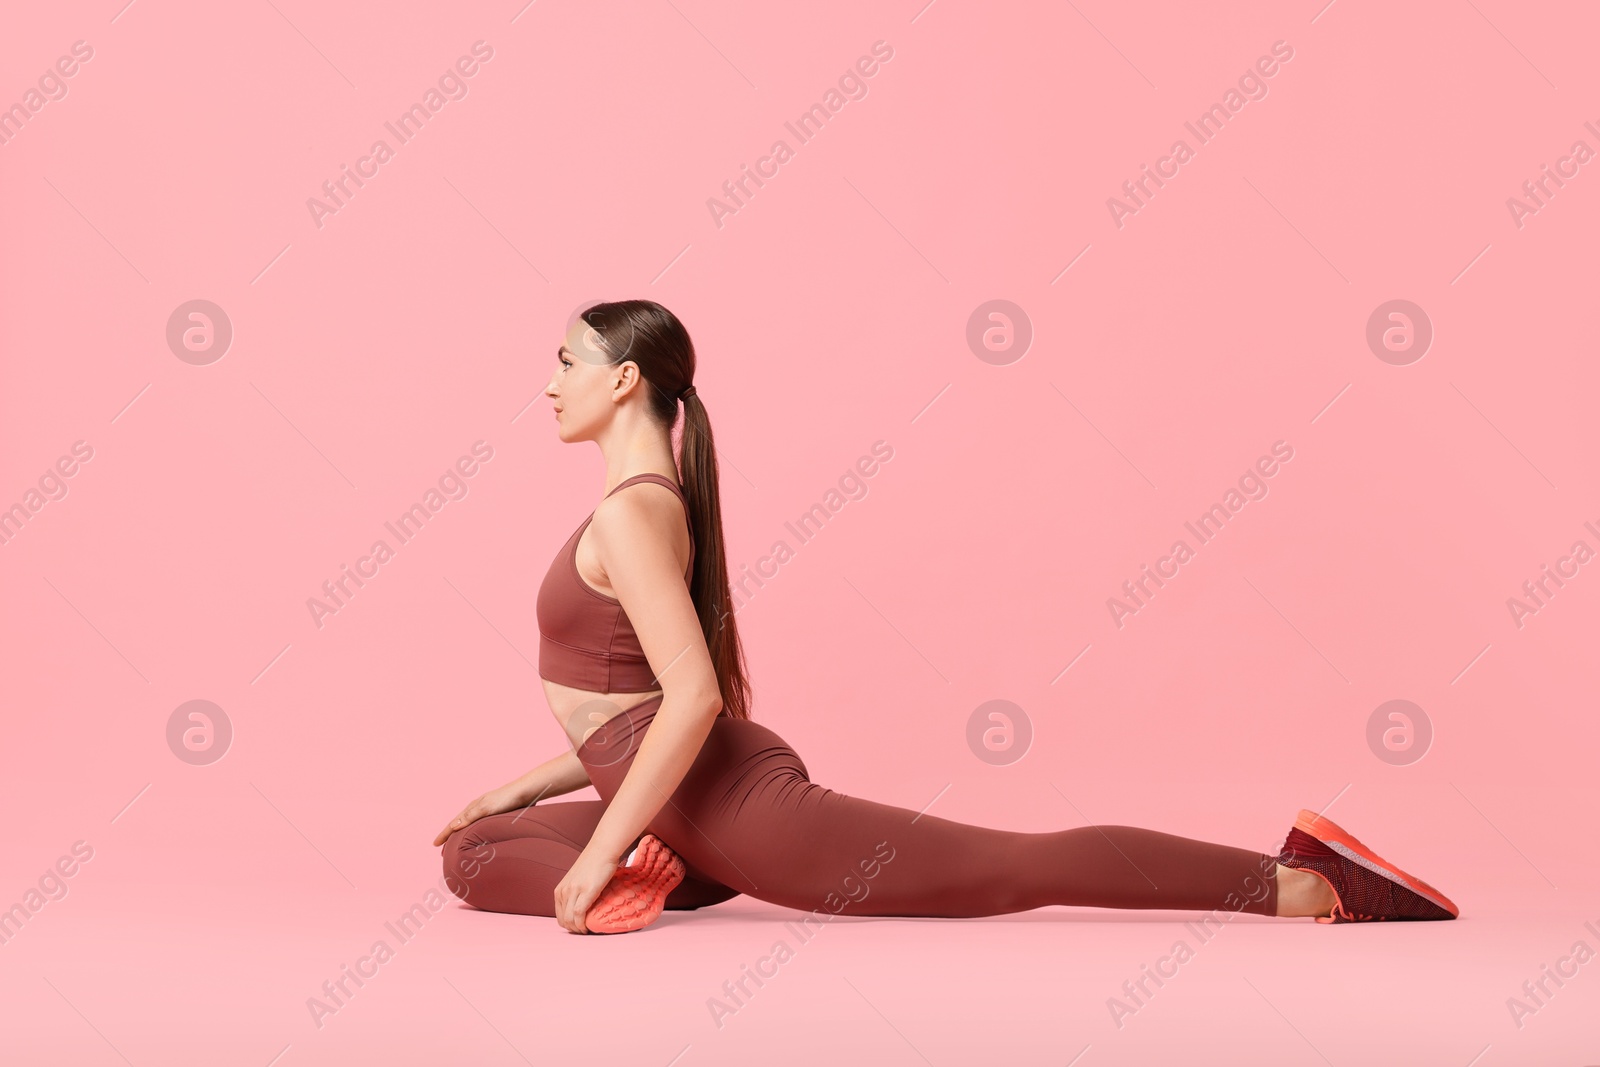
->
[434,301,1458,933]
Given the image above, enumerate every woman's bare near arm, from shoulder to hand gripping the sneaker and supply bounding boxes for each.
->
[555,486,722,933]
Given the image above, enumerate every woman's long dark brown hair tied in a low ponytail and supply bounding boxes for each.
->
[579,301,750,718]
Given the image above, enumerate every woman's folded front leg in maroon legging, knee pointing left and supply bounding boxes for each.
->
[443,800,738,917]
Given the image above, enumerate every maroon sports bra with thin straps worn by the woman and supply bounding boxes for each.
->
[534,474,694,693]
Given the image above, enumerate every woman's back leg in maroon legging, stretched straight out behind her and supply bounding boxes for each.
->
[643,774,1277,917]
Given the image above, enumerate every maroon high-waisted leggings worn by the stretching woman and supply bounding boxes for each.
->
[445,696,1278,918]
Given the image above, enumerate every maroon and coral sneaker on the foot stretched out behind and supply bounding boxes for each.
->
[1278,808,1461,923]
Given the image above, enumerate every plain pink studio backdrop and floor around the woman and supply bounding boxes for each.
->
[0,0,1600,1067]
